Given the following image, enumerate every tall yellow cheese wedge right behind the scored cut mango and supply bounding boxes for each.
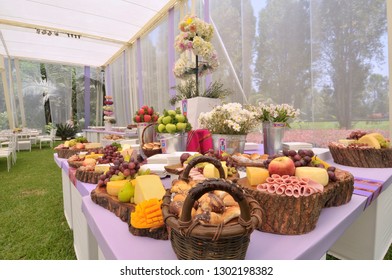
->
[134,175,165,204]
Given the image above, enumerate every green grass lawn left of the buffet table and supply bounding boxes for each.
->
[0,140,392,260]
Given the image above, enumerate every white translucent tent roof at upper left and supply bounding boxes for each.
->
[0,0,176,66]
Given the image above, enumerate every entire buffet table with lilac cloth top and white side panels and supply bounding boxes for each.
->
[55,149,392,260]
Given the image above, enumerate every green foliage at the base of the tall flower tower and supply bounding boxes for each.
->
[169,79,232,105]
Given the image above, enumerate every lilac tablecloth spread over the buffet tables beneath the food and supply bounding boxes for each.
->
[55,145,392,260]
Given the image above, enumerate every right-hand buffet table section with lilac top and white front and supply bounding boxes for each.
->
[327,153,392,260]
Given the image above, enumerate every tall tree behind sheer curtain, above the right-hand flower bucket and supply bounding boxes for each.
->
[255,0,311,109]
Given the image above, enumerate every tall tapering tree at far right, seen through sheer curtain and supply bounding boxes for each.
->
[312,0,386,128]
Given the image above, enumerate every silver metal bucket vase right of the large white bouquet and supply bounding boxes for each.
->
[263,122,286,155]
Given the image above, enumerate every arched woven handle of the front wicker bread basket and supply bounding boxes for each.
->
[180,179,251,222]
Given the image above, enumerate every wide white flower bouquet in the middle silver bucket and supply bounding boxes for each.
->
[199,103,258,135]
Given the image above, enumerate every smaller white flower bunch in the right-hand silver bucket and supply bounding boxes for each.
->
[251,103,300,127]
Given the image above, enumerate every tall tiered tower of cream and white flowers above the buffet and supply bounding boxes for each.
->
[173,15,219,79]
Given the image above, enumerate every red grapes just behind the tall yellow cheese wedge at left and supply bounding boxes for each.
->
[98,158,140,187]
